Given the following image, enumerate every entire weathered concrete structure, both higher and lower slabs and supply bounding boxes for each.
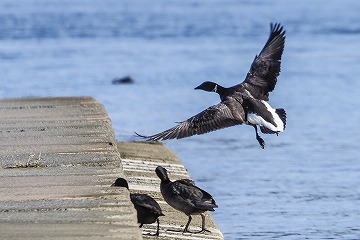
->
[0,97,223,239]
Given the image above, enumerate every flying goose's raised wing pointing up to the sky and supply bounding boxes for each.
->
[237,23,285,101]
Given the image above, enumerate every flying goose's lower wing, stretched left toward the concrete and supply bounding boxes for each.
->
[136,100,245,141]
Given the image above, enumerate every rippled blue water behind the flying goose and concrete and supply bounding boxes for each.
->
[0,0,360,239]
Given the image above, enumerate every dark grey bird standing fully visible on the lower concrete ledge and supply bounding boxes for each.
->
[155,166,218,233]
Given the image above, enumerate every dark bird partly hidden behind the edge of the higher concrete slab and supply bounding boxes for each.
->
[111,178,164,236]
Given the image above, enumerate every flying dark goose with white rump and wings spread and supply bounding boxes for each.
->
[136,24,286,148]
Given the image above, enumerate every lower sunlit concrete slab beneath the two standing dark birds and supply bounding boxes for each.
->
[118,142,224,240]
